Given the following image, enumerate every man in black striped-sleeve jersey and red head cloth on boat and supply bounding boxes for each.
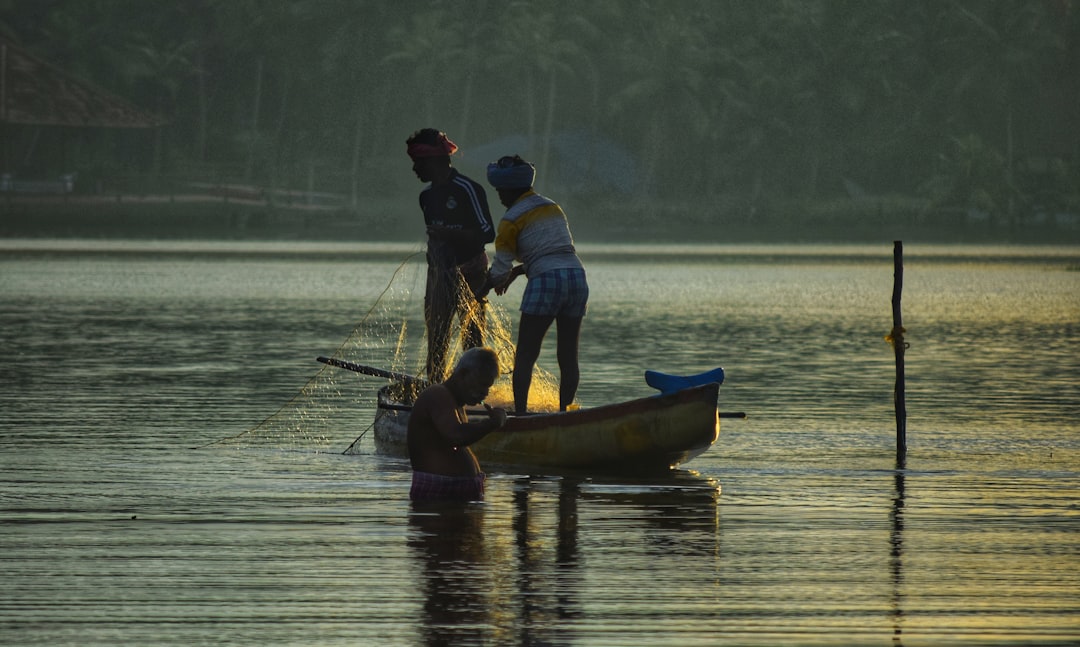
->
[406,129,495,382]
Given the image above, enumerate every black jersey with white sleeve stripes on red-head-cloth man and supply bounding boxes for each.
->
[420,169,495,265]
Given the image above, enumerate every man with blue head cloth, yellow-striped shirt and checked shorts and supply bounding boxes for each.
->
[487,156,589,413]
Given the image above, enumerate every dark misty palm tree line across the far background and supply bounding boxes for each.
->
[0,0,1080,235]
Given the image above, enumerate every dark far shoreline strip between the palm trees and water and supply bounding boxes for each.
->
[0,194,1080,245]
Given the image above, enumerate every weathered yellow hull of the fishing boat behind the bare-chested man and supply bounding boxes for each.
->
[375,382,720,473]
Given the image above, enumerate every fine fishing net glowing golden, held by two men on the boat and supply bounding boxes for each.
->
[212,252,558,454]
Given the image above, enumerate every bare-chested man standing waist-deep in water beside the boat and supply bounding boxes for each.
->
[408,348,507,501]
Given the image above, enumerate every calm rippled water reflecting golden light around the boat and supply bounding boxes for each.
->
[0,241,1080,646]
